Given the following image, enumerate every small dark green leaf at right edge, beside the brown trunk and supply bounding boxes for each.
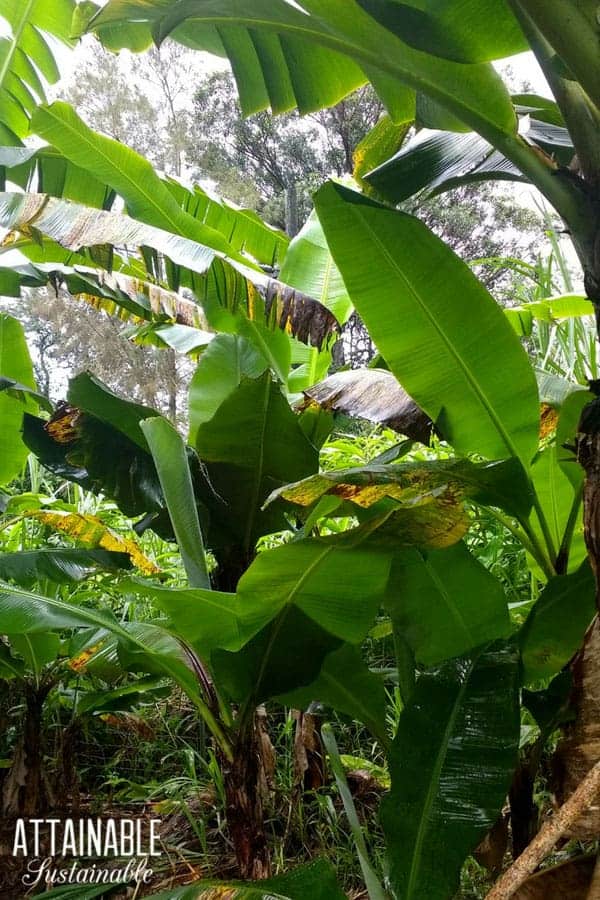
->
[519,562,596,684]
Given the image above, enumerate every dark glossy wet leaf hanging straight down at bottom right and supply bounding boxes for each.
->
[381,643,519,900]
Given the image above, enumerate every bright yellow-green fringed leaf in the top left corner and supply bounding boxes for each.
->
[0,0,75,145]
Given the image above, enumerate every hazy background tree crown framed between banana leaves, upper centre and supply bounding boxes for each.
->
[189,71,383,236]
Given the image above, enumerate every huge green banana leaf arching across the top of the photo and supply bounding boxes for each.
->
[91,0,515,141]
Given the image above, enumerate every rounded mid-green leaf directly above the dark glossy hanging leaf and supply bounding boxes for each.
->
[386,543,510,666]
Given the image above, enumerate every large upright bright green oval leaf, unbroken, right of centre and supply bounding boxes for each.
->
[316,183,539,467]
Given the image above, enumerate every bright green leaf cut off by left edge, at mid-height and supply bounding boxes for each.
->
[0,313,35,484]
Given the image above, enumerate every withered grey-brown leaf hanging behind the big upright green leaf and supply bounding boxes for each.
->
[305,369,433,444]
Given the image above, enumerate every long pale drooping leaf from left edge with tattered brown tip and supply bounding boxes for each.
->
[0,193,338,347]
